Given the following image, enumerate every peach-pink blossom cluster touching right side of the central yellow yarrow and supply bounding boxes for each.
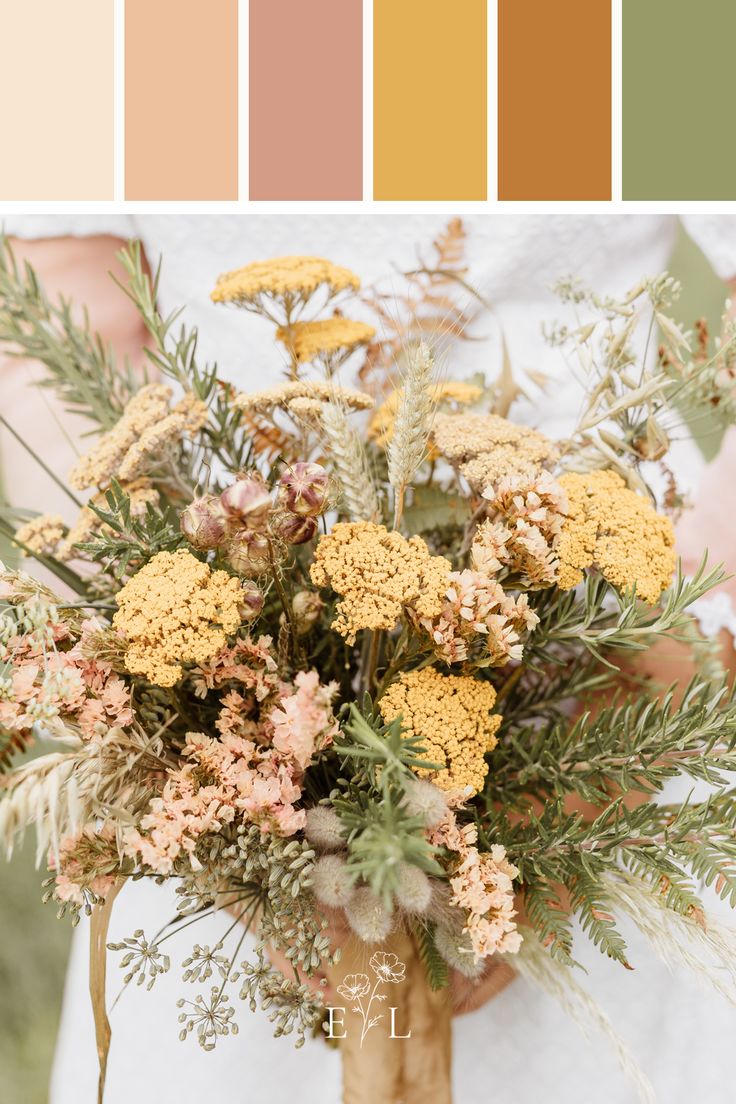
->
[416,570,538,667]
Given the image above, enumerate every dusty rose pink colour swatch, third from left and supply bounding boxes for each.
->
[249,0,363,200]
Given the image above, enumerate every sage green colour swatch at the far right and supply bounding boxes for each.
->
[622,0,736,200]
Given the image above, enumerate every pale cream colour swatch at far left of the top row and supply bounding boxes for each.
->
[0,0,115,200]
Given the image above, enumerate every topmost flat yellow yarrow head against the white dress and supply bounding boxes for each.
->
[212,257,361,306]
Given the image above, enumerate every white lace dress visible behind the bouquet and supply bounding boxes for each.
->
[8,214,736,1104]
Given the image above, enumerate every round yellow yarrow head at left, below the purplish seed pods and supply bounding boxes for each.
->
[113,551,243,687]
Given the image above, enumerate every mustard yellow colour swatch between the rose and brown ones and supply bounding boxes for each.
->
[373,0,488,200]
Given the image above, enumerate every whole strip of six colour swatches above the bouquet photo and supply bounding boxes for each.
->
[0,0,736,203]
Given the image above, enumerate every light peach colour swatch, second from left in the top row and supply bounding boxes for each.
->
[125,0,237,200]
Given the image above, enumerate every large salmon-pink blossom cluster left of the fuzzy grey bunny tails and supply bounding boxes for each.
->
[125,666,337,874]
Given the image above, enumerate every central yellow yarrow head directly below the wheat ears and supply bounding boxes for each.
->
[310,521,451,644]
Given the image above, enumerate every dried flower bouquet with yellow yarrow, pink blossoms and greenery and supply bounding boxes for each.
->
[0,235,736,1098]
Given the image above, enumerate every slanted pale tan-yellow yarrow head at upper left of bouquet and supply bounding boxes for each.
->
[68,383,207,490]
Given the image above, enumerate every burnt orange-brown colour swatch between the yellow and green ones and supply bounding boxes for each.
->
[499,0,611,200]
